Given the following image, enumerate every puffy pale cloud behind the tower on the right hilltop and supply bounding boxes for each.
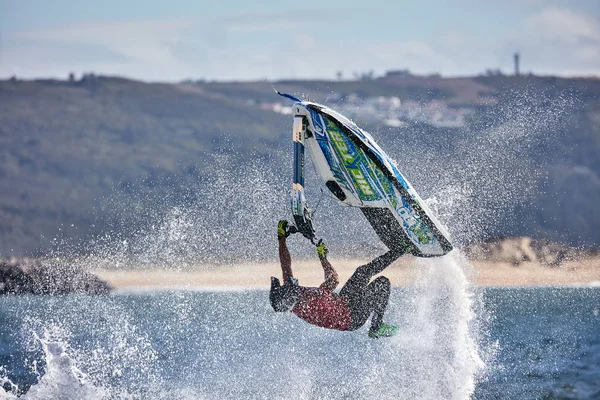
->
[418,7,600,76]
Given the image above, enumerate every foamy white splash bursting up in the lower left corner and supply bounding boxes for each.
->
[0,296,160,400]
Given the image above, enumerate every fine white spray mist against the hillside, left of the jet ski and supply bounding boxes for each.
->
[87,154,289,270]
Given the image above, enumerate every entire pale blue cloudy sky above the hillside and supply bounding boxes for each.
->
[0,0,600,82]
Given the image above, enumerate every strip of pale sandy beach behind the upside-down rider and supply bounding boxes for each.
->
[94,257,600,290]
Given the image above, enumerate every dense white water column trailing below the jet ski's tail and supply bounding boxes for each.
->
[408,251,484,399]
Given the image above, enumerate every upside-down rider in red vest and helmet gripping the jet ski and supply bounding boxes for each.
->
[269,220,404,338]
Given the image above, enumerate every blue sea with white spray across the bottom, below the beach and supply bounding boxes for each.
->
[0,260,600,399]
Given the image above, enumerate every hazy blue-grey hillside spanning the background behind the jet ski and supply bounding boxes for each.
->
[0,75,600,258]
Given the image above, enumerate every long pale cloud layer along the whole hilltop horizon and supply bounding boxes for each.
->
[0,7,600,81]
